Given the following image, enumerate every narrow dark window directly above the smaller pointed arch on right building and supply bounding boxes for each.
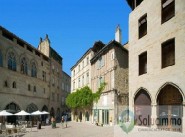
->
[139,52,147,75]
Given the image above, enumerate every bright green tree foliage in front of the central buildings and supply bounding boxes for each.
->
[66,83,106,109]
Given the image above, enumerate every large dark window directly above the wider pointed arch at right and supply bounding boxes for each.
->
[162,39,175,68]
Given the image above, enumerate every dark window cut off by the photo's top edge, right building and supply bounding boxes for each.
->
[161,0,175,23]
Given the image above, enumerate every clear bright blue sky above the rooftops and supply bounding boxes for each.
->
[0,0,131,75]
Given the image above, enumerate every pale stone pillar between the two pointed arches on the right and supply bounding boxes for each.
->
[151,103,157,128]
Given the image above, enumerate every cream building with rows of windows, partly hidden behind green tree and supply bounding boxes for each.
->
[71,48,94,121]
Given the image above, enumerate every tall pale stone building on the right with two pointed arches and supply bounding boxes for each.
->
[127,0,185,132]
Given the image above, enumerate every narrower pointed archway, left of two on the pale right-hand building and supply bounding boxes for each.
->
[134,89,151,126]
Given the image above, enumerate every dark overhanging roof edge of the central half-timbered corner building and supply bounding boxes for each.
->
[91,40,128,63]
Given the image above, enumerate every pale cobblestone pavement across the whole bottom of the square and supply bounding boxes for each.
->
[22,122,185,137]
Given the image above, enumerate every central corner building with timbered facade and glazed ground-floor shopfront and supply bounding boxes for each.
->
[91,40,128,125]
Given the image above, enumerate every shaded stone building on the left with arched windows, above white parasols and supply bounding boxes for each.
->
[0,27,65,122]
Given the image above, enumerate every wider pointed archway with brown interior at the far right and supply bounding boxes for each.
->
[157,84,183,131]
